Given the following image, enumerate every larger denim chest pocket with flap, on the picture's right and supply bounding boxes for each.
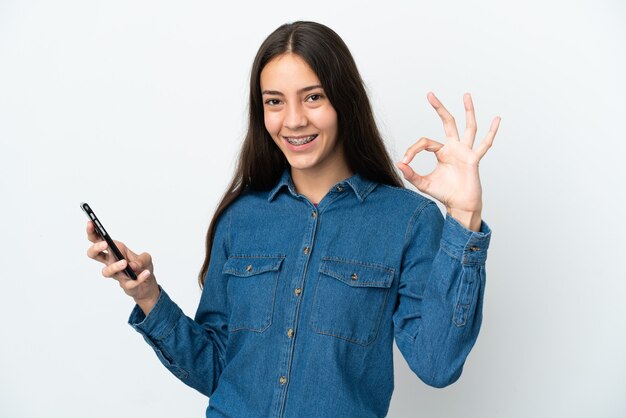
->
[311,257,393,345]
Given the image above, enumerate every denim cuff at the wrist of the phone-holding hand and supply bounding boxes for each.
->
[128,286,183,340]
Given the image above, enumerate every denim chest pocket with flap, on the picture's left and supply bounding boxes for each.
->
[222,255,284,332]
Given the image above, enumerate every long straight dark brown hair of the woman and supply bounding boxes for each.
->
[198,21,404,287]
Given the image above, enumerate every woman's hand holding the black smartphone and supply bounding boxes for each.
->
[87,221,161,315]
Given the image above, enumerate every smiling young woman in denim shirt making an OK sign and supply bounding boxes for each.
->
[87,22,499,417]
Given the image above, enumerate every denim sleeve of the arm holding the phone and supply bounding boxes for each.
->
[128,211,229,396]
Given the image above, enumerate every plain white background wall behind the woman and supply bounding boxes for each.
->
[0,0,626,418]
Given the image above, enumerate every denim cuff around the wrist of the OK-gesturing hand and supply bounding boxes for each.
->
[441,214,491,264]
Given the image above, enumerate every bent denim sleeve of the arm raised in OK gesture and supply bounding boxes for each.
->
[393,202,491,387]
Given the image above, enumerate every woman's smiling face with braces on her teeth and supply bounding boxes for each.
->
[261,53,347,175]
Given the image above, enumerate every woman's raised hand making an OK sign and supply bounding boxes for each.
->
[396,92,500,231]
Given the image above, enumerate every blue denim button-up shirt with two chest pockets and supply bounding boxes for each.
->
[129,170,490,417]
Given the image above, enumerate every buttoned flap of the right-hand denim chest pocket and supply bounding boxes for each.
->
[319,257,393,287]
